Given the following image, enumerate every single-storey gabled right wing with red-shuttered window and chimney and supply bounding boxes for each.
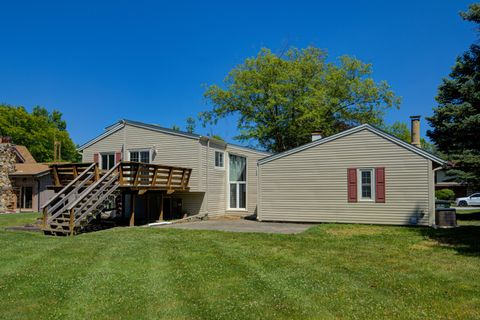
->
[258,119,445,225]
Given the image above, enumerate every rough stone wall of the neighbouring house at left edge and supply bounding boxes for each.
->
[0,141,16,213]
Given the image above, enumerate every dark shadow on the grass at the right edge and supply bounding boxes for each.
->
[421,212,480,256]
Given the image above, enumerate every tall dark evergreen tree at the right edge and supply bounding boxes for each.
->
[427,4,480,186]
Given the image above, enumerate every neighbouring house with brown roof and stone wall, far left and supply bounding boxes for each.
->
[1,137,53,212]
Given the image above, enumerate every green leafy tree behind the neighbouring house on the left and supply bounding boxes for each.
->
[0,104,79,162]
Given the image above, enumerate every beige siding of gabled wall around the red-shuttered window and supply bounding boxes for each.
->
[259,129,433,225]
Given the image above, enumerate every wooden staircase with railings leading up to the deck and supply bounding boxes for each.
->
[42,163,120,235]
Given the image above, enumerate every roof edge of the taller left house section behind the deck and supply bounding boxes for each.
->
[77,119,271,155]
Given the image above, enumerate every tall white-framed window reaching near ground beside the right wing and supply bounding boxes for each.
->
[228,154,247,209]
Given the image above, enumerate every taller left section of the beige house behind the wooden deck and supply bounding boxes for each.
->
[78,120,270,223]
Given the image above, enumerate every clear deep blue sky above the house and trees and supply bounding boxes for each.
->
[0,0,475,144]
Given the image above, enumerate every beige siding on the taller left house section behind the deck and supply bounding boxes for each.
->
[83,124,268,216]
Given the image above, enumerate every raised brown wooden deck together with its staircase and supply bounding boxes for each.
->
[42,161,192,235]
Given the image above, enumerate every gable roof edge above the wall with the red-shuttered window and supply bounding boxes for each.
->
[258,124,447,165]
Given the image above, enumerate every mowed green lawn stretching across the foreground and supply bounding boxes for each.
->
[0,213,480,319]
